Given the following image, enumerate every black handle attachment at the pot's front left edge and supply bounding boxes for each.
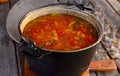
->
[19,39,52,58]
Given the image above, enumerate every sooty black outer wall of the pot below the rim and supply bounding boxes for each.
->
[27,45,97,76]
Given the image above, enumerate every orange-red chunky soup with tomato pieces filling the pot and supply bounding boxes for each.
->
[23,14,98,51]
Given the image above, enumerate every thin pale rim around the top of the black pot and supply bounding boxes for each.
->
[18,6,104,53]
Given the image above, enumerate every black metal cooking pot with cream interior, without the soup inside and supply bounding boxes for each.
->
[19,6,103,76]
